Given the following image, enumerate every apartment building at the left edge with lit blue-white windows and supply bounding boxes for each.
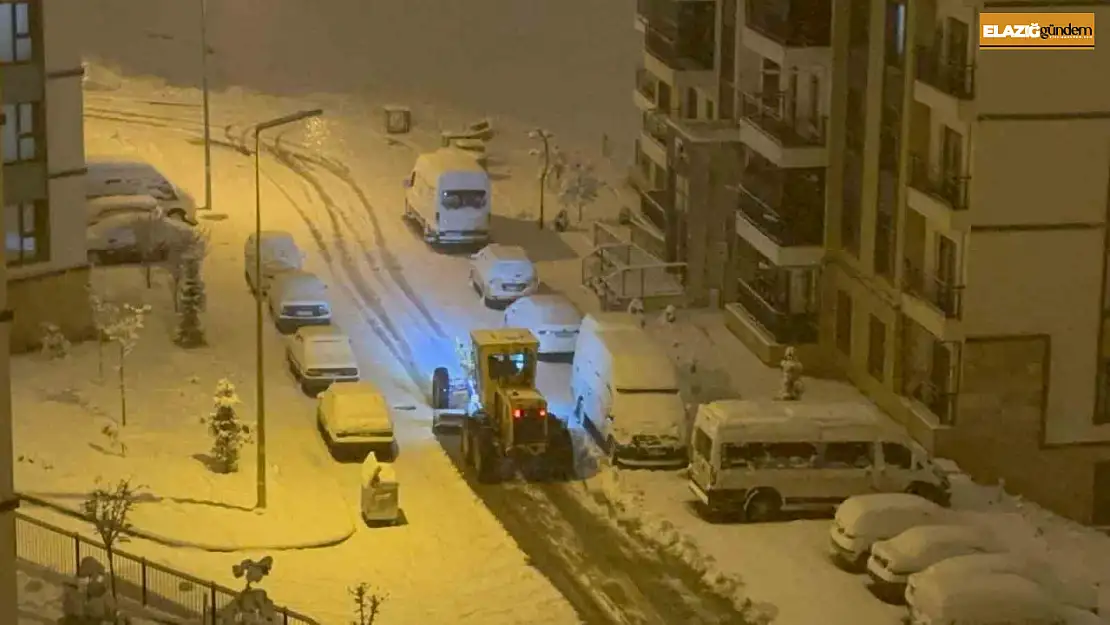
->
[0,0,91,351]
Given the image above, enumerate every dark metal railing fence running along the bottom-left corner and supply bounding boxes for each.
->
[16,513,320,625]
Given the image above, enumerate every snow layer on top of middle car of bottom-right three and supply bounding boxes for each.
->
[871,525,1005,568]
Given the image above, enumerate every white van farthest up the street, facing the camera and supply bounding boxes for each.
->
[404,148,492,245]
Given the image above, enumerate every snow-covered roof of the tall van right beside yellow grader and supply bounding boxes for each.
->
[598,326,678,391]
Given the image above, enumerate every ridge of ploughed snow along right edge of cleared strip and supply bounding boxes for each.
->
[584,464,777,623]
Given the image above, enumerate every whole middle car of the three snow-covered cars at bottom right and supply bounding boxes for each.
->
[867,525,1006,601]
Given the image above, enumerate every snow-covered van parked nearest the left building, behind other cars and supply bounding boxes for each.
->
[84,157,196,225]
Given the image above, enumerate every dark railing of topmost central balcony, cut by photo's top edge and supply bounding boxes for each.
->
[745,0,833,48]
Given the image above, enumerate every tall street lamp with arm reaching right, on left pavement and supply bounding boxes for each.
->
[254,109,324,510]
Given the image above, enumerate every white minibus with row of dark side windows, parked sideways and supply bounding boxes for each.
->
[689,400,949,521]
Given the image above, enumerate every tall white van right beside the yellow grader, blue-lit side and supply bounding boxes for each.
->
[571,315,689,467]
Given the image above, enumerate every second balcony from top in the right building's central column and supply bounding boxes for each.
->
[740,93,828,168]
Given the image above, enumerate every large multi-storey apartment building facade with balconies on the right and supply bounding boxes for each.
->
[632,0,1110,525]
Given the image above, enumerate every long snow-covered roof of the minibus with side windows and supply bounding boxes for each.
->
[696,400,907,441]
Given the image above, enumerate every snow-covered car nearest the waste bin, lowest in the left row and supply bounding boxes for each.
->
[316,381,394,461]
